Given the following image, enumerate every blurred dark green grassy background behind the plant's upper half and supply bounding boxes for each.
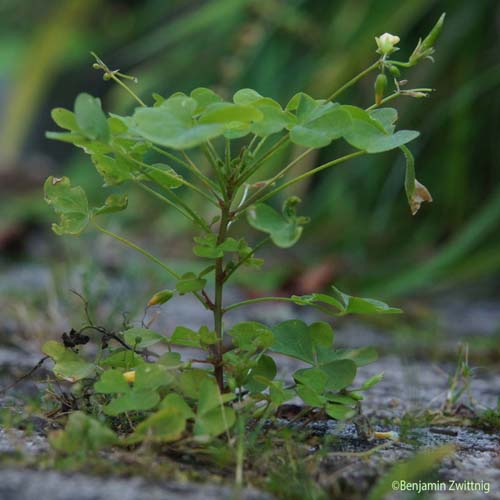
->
[0,0,500,306]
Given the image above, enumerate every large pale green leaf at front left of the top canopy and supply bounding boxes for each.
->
[130,95,225,149]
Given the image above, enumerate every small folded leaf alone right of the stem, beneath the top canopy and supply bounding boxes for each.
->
[247,203,302,248]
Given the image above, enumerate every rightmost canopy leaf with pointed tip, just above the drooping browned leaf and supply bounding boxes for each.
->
[342,106,420,153]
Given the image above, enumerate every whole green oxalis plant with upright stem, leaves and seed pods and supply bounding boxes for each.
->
[43,15,444,458]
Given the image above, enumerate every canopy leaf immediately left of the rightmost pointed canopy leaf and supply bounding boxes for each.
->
[290,94,351,148]
